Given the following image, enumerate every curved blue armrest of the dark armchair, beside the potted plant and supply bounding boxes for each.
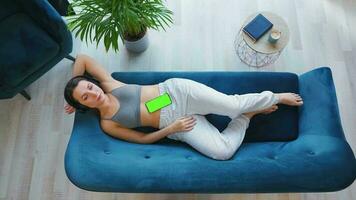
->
[17,0,72,52]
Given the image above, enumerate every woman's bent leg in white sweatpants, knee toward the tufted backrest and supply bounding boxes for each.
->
[175,115,250,160]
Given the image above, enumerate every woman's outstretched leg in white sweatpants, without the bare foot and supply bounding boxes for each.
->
[177,79,278,119]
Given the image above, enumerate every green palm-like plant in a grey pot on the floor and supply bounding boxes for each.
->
[67,0,173,52]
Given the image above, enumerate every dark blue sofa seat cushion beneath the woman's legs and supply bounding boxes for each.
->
[112,72,298,142]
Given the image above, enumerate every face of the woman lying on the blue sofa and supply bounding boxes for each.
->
[73,80,106,108]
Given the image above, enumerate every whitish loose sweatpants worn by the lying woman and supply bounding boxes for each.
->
[158,78,278,160]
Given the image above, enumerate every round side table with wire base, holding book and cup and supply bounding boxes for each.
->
[234,12,289,67]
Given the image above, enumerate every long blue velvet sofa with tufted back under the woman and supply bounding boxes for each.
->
[65,67,356,193]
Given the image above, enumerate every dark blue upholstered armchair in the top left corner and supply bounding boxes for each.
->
[0,0,72,99]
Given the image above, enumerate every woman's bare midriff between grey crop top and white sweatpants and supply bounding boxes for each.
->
[140,85,161,128]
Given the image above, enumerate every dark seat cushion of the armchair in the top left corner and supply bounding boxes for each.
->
[0,13,59,87]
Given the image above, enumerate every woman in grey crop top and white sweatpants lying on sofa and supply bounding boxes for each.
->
[64,55,303,160]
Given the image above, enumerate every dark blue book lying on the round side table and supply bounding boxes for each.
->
[243,14,273,42]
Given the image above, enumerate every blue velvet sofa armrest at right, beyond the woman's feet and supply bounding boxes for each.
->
[299,67,345,140]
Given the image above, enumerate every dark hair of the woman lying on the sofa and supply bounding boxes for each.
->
[64,75,103,112]
